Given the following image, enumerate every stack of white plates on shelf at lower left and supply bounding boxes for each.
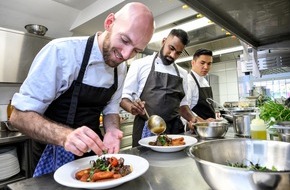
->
[0,147,20,180]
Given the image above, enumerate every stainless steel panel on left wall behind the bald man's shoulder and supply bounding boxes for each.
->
[0,27,52,83]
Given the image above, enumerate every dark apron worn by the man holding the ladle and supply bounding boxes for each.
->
[132,54,185,147]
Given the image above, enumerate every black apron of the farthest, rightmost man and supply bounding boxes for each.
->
[191,72,215,119]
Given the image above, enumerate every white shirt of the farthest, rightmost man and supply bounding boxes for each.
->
[187,70,209,109]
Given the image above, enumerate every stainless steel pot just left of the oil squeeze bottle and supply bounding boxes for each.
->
[233,113,256,137]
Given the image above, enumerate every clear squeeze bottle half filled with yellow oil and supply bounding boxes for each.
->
[250,113,267,140]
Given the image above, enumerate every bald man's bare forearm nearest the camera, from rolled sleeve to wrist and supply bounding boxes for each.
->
[10,109,72,146]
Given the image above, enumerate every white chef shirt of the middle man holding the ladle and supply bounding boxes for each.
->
[122,53,188,106]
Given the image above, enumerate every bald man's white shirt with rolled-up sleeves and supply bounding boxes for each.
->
[12,34,127,115]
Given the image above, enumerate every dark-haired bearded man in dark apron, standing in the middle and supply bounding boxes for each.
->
[121,29,195,147]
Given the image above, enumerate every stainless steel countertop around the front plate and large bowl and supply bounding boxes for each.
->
[8,128,241,190]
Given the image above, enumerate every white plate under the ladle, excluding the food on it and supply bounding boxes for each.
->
[139,135,197,152]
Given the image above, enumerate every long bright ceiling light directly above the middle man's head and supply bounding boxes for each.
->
[149,17,213,43]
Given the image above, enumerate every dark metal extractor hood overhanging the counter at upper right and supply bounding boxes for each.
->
[181,0,290,50]
